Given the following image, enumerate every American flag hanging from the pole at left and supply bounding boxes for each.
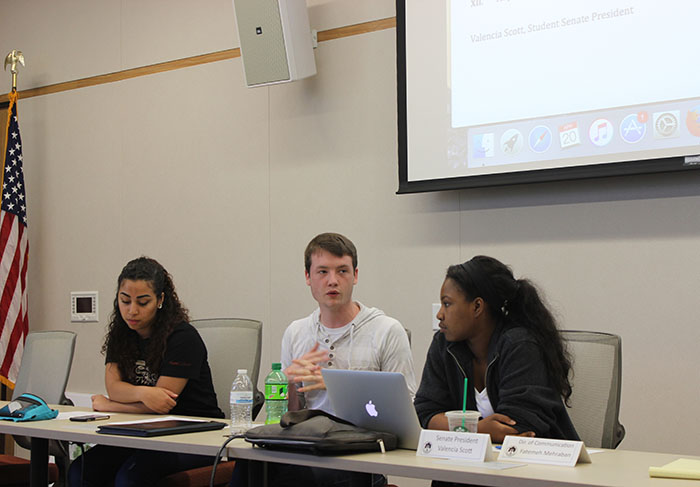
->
[0,92,29,387]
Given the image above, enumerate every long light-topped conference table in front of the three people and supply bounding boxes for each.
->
[0,401,698,487]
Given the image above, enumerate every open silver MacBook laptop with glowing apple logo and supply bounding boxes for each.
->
[321,369,421,450]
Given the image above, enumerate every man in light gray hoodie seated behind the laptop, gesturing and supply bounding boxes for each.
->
[282,233,416,414]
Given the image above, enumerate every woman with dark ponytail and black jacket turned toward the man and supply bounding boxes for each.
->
[415,256,578,443]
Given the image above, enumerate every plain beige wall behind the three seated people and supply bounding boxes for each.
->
[0,0,700,466]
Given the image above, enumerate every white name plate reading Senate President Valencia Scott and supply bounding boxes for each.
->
[416,430,495,462]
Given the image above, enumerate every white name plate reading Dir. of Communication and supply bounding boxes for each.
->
[498,436,591,467]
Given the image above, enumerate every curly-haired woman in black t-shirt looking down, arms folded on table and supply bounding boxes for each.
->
[70,257,224,487]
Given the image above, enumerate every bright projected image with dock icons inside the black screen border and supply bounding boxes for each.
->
[397,0,700,190]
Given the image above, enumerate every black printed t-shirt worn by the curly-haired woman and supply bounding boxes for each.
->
[105,322,224,418]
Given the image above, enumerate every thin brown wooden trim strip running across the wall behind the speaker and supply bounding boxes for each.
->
[0,17,396,103]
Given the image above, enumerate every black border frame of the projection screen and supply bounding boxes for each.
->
[396,0,700,194]
